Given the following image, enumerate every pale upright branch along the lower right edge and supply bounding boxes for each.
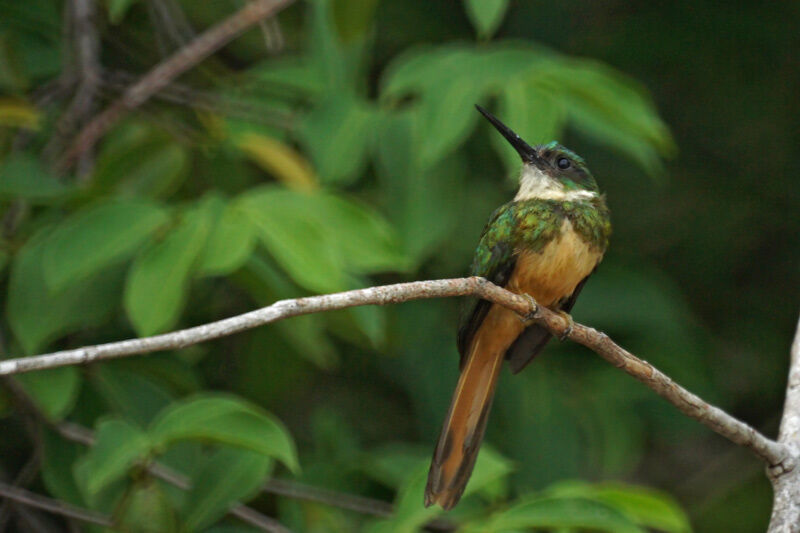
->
[767,319,800,533]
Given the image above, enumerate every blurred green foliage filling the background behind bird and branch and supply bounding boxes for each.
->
[0,0,800,532]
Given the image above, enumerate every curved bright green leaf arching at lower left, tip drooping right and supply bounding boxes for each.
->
[149,394,299,471]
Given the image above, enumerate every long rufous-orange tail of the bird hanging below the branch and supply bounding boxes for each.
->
[425,327,507,510]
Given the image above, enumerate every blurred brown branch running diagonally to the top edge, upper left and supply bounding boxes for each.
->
[59,0,292,170]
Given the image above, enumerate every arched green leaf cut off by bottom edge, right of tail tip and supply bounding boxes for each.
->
[466,498,645,533]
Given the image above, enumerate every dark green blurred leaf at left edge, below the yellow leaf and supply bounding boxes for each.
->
[0,152,70,201]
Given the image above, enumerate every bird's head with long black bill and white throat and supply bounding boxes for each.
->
[475,106,600,200]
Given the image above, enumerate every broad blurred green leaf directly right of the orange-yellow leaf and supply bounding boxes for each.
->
[300,94,374,184]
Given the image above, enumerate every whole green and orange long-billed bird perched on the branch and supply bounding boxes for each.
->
[424,105,611,510]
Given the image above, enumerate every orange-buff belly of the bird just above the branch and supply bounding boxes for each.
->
[509,221,603,307]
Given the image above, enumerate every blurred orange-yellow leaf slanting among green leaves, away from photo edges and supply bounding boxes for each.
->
[236,132,319,191]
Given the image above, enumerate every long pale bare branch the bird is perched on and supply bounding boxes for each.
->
[0,277,800,472]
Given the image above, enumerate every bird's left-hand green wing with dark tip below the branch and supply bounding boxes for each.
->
[458,202,516,366]
